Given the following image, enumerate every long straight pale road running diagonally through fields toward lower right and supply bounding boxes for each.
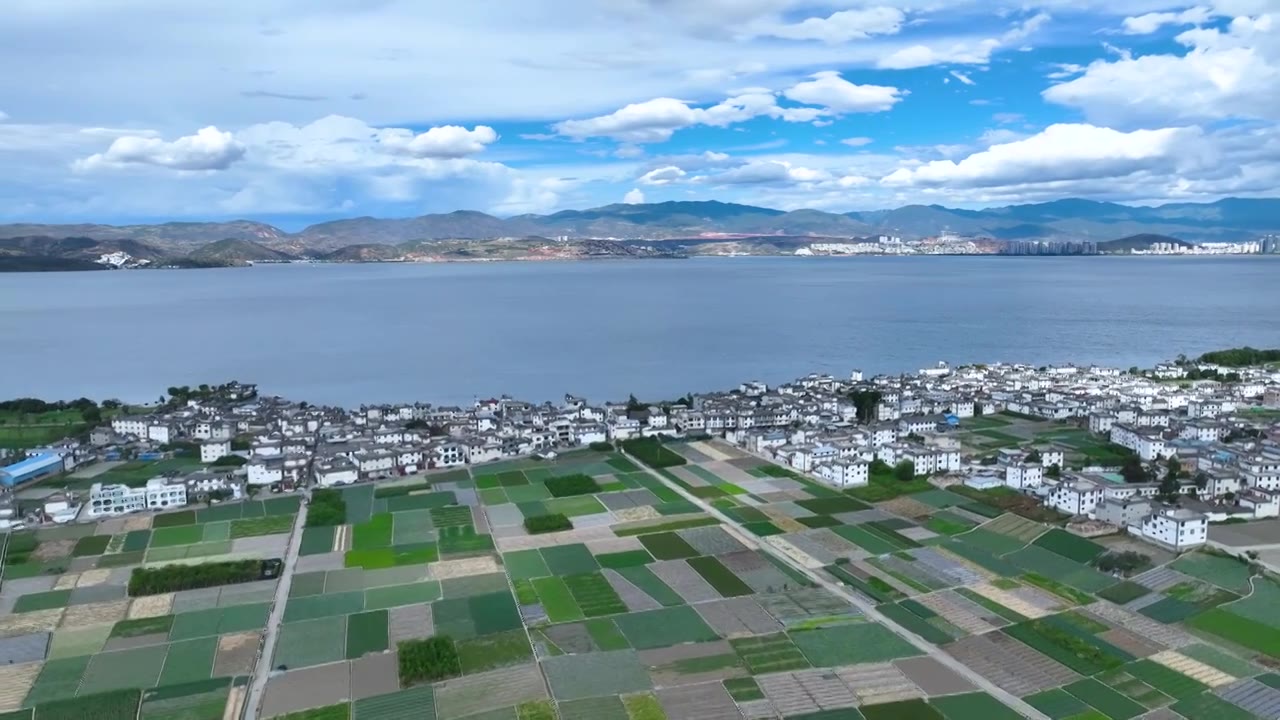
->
[623,451,1048,720]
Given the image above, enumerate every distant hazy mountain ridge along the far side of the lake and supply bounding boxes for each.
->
[0,197,1280,256]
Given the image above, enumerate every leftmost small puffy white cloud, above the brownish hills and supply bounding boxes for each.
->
[78,126,244,170]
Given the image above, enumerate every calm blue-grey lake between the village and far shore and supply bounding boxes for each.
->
[0,258,1280,406]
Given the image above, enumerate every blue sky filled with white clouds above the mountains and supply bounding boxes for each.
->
[0,0,1280,229]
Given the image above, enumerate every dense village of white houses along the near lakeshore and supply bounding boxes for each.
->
[0,363,1280,550]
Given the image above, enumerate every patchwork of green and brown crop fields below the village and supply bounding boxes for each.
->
[10,438,1280,720]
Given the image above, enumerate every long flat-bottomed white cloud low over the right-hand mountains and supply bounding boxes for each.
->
[881,124,1201,187]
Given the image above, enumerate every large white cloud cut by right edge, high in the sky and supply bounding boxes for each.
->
[1043,15,1280,126]
